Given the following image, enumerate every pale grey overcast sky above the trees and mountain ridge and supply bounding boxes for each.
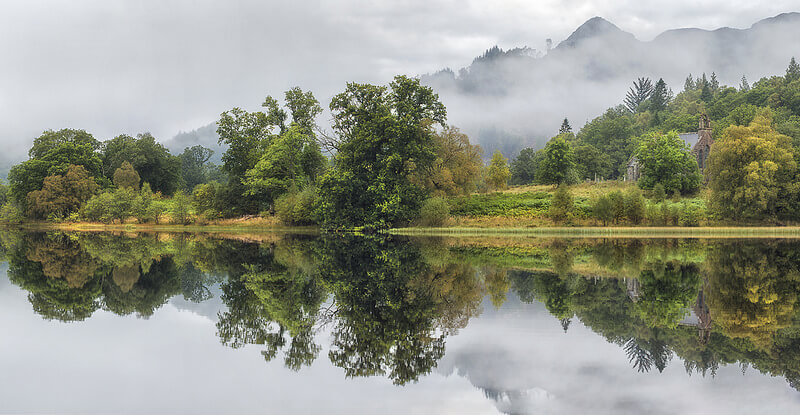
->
[0,0,800,160]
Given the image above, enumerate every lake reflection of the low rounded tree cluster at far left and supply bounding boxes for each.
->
[5,233,219,321]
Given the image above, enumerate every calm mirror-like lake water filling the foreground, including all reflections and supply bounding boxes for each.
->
[0,232,800,414]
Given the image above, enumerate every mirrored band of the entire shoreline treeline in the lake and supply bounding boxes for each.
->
[2,233,800,387]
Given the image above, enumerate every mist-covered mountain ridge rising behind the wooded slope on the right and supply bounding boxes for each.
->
[422,13,800,157]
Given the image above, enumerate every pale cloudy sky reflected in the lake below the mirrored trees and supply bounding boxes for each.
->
[0,272,800,414]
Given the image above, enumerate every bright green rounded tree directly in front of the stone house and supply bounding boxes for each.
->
[636,132,701,194]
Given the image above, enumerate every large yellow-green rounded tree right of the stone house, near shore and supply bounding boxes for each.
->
[706,112,798,220]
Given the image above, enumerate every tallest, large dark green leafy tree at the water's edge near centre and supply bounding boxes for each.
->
[319,76,446,228]
